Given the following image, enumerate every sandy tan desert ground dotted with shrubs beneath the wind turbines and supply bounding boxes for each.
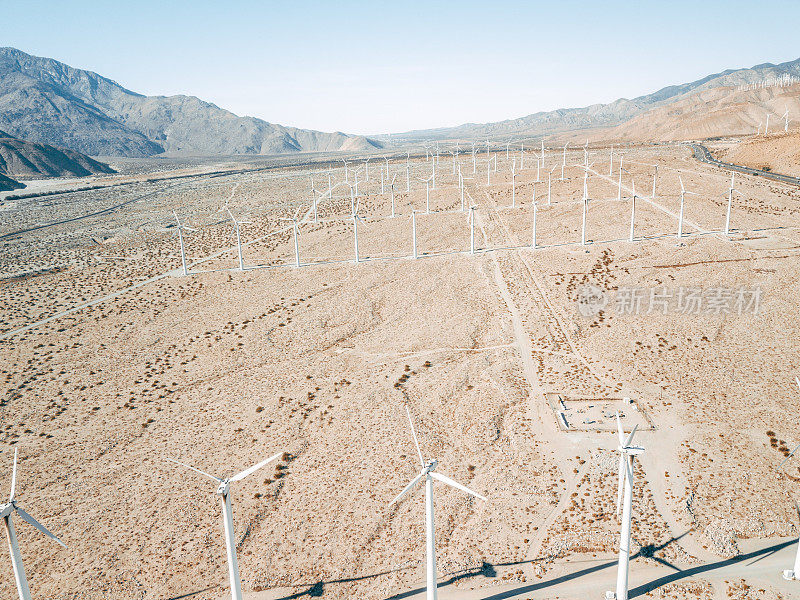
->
[0,140,800,600]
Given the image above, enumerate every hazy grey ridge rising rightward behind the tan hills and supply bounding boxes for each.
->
[388,59,800,144]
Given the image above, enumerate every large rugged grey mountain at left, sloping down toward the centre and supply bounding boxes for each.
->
[0,48,381,157]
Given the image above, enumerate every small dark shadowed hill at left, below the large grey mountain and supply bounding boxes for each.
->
[0,131,115,178]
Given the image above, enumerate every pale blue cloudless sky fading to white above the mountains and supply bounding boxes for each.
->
[6,0,800,134]
